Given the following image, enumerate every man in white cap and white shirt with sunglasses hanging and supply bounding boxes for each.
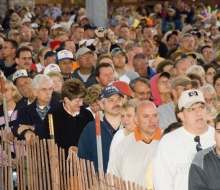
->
[153,90,215,190]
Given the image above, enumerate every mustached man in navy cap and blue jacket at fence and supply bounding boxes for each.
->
[78,85,123,172]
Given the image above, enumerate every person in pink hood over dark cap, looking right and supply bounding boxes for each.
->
[150,72,172,107]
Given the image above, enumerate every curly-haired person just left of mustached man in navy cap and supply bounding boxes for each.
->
[84,85,102,118]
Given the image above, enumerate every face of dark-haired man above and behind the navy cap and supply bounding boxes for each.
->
[96,67,115,87]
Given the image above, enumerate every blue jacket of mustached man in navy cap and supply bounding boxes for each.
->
[78,117,116,172]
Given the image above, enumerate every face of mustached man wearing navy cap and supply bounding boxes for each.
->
[100,94,122,116]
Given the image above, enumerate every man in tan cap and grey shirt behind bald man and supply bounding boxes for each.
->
[158,75,195,130]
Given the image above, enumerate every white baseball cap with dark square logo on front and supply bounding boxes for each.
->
[178,90,205,110]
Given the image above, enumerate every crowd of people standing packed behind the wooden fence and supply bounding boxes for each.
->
[0,0,220,190]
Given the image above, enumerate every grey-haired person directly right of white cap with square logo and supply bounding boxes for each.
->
[199,84,218,106]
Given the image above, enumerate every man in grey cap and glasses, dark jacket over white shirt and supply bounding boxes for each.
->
[73,47,97,88]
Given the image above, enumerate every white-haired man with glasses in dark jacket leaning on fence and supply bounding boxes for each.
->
[12,74,59,142]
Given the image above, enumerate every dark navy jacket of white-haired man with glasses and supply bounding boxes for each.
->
[12,98,60,139]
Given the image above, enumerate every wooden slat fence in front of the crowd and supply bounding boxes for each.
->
[0,131,147,190]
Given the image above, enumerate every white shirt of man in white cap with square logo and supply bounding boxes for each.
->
[153,127,215,190]
